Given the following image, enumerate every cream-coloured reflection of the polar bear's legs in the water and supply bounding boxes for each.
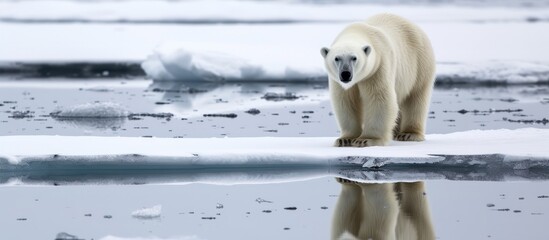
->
[331,178,435,240]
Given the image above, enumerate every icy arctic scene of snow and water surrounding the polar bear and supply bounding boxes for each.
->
[0,0,549,240]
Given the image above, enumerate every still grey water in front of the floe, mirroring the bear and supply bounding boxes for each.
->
[0,177,549,239]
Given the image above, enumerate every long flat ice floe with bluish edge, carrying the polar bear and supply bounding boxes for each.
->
[0,128,549,184]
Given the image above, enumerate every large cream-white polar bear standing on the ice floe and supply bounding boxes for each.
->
[321,14,435,147]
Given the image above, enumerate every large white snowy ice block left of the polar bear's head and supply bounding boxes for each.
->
[141,43,325,81]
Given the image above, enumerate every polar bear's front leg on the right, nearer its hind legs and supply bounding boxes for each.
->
[353,79,398,147]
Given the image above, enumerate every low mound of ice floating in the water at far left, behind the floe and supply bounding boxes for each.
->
[50,102,130,118]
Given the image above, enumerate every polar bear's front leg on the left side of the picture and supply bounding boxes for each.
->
[329,79,362,147]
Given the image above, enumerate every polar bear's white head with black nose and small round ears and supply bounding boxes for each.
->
[320,45,374,89]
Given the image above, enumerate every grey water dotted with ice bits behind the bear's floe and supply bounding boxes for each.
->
[0,79,549,137]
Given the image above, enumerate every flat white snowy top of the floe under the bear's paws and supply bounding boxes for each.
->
[0,128,549,167]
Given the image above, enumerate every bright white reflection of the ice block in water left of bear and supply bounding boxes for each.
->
[144,82,328,117]
